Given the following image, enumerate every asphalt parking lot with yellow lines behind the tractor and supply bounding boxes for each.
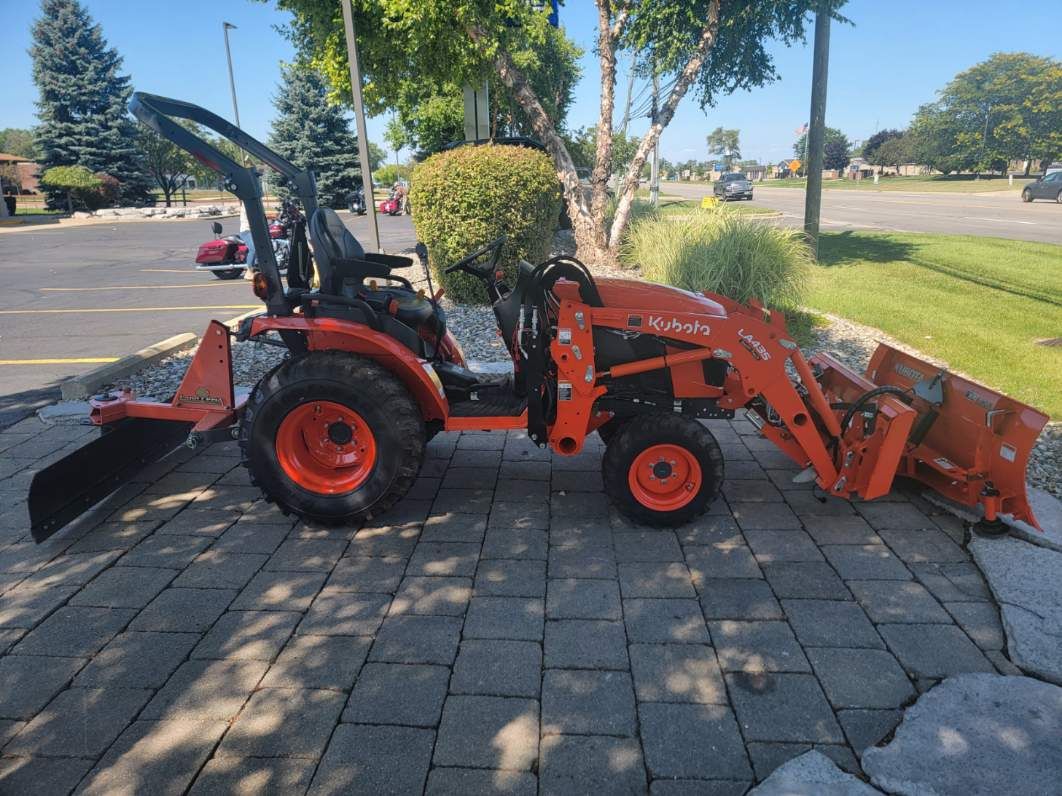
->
[0,212,412,428]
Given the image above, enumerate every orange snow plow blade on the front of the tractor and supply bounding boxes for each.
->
[867,343,1048,529]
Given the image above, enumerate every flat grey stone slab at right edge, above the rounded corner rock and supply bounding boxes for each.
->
[970,536,1062,683]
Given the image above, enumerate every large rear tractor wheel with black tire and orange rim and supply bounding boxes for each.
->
[240,351,425,524]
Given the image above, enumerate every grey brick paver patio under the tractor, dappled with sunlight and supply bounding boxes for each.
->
[0,419,1012,794]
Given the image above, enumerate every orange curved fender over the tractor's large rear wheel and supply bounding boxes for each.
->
[250,315,449,420]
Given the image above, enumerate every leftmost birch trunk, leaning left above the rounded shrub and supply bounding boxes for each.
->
[477,28,609,262]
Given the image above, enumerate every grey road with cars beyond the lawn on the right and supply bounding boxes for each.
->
[661,183,1062,243]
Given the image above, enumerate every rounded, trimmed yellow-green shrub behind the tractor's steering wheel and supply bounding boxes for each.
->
[410,144,561,304]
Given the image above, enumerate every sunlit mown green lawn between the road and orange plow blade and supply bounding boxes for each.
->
[807,231,1062,419]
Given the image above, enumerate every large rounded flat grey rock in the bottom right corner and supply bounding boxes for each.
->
[861,674,1062,796]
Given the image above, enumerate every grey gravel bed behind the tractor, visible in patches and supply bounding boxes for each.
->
[103,231,1062,499]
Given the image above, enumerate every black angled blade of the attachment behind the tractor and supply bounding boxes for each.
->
[29,417,192,541]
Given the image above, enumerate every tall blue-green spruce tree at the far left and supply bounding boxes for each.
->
[30,0,151,203]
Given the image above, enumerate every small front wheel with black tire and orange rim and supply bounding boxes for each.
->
[601,414,723,526]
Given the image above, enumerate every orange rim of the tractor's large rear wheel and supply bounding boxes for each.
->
[276,401,376,495]
